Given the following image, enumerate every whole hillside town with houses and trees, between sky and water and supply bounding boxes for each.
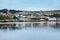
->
[0,9,60,22]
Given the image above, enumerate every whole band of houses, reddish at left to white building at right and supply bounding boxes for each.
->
[0,11,56,20]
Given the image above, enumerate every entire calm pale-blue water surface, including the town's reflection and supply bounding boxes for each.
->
[0,22,60,40]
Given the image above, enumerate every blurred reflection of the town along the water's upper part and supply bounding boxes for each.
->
[0,22,60,29]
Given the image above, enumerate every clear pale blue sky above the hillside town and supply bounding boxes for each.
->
[0,0,60,11]
